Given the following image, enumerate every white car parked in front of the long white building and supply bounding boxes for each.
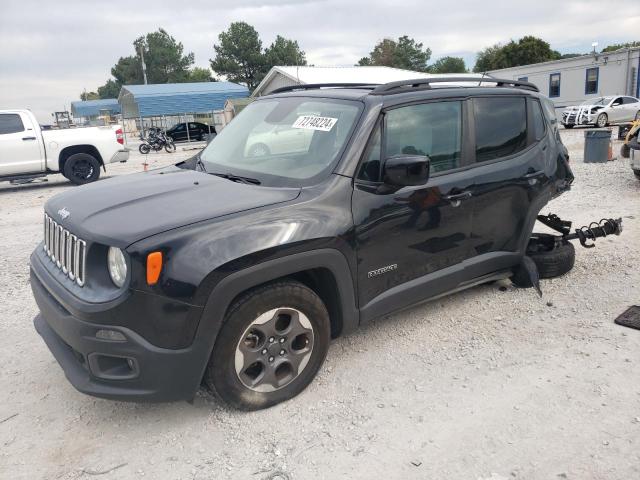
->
[561,96,640,128]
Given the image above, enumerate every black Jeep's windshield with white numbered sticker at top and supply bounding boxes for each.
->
[200,97,361,186]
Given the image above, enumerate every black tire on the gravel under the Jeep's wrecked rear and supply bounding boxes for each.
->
[511,233,576,288]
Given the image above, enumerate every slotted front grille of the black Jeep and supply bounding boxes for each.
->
[44,213,87,287]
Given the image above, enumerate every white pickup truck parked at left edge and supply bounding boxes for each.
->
[0,110,129,185]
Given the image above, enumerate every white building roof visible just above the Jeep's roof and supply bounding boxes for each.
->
[253,66,480,96]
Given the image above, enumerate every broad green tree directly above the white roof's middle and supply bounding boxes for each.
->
[358,35,431,72]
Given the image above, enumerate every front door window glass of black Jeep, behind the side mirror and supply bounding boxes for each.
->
[385,101,462,173]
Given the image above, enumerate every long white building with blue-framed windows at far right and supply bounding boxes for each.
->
[487,47,640,114]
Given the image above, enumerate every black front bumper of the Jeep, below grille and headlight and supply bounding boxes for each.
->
[31,262,209,402]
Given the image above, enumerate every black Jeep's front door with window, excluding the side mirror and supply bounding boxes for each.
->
[352,101,473,321]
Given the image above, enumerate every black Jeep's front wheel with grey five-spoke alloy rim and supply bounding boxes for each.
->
[204,281,331,410]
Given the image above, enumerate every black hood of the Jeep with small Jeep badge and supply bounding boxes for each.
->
[45,167,300,248]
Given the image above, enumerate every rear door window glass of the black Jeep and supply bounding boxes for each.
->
[473,97,527,162]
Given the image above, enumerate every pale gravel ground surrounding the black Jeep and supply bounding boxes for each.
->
[0,130,640,480]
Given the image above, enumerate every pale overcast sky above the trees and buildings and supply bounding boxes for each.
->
[0,0,640,123]
